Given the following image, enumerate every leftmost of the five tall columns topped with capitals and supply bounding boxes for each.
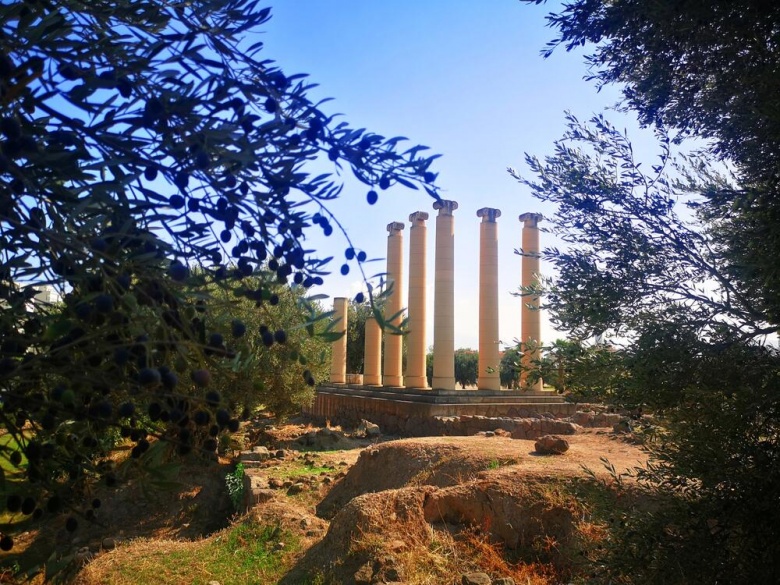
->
[383,221,404,386]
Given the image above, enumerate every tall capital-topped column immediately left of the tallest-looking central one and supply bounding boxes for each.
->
[404,211,428,388]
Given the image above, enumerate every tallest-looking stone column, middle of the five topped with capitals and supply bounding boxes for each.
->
[433,199,458,390]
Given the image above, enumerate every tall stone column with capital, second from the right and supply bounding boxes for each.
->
[477,207,501,390]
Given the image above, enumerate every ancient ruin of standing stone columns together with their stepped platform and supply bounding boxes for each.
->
[305,200,556,431]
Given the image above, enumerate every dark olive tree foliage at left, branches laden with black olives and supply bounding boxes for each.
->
[0,0,436,549]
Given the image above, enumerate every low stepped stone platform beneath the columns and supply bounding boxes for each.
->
[303,384,577,434]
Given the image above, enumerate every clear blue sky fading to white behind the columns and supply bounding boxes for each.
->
[254,0,655,348]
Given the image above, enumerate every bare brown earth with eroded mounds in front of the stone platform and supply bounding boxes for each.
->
[4,423,647,585]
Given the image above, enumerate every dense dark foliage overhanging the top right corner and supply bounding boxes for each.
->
[533,0,780,181]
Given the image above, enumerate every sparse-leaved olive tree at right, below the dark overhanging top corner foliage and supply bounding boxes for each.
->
[521,116,780,583]
